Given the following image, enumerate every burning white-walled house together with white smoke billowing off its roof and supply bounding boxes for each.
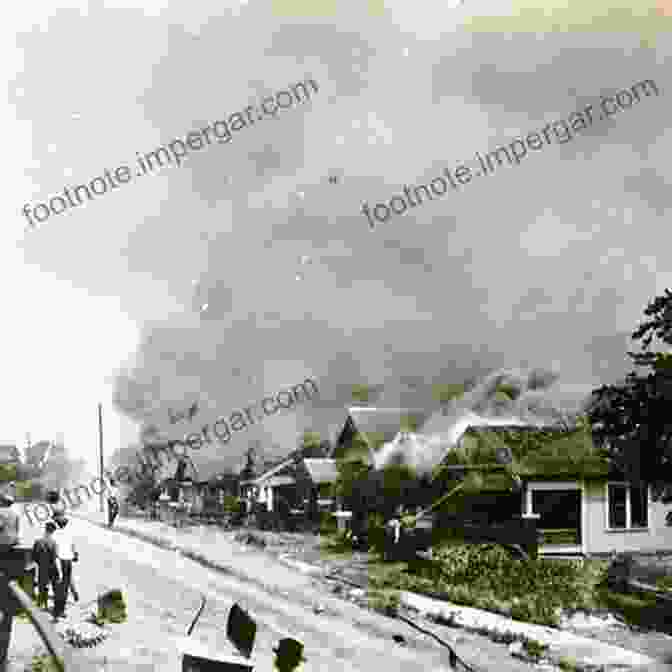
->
[373,371,672,556]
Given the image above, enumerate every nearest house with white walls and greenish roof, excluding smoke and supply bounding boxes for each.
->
[428,426,672,555]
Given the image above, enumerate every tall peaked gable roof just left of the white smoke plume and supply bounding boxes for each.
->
[332,406,430,461]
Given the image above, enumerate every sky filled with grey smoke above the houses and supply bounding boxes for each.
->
[5,0,672,476]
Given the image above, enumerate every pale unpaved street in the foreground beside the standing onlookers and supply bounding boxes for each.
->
[10,518,531,672]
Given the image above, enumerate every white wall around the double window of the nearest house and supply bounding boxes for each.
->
[584,480,672,554]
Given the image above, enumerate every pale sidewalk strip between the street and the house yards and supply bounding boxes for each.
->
[71,511,672,672]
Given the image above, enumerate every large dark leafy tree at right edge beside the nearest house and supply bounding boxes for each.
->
[587,289,672,499]
